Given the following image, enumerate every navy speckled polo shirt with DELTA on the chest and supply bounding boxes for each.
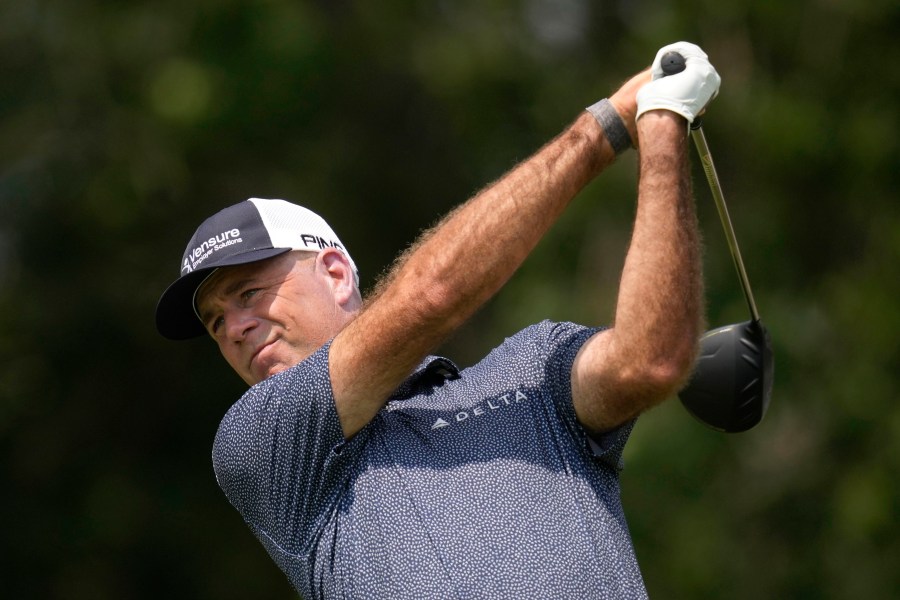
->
[213,321,646,600]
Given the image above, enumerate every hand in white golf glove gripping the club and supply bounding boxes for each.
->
[635,42,722,123]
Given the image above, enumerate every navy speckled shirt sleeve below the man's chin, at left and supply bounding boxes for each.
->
[213,344,347,556]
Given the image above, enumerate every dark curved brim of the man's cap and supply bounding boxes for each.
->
[156,248,291,340]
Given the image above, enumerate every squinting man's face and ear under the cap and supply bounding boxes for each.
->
[197,252,346,385]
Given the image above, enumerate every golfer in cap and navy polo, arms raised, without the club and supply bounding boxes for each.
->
[156,42,719,600]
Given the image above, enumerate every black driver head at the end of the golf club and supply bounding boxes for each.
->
[678,320,774,433]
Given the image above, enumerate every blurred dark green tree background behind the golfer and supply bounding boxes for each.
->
[0,0,900,599]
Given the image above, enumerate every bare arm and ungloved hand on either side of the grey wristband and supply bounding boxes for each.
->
[330,73,649,438]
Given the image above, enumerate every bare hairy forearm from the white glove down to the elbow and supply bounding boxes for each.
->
[612,113,703,388]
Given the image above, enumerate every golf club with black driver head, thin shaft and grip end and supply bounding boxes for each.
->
[662,52,774,433]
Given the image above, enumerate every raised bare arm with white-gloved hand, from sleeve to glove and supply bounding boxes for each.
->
[572,43,719,433]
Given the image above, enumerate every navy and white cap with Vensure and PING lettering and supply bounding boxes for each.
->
[156,198,359,340]
